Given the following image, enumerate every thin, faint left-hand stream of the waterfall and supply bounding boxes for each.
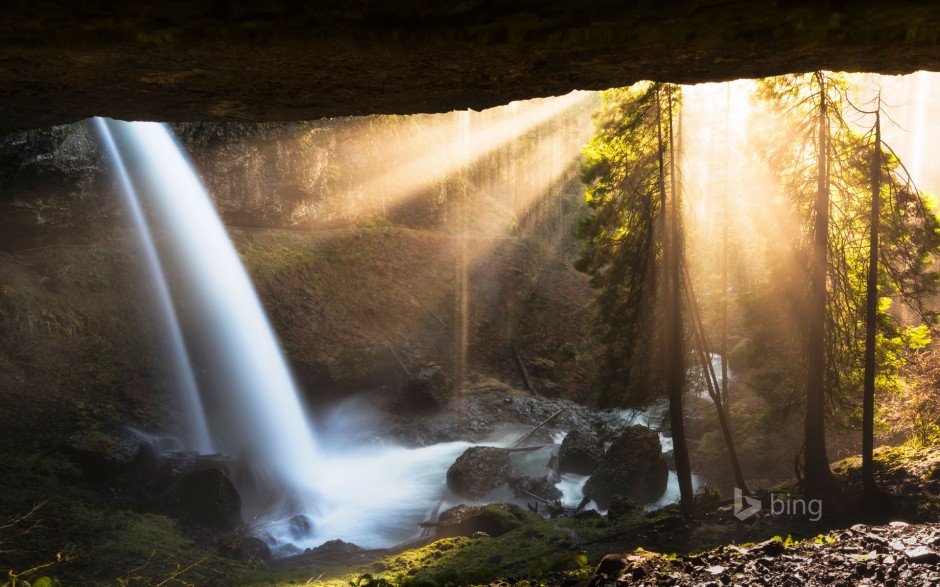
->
[95,118,212,453]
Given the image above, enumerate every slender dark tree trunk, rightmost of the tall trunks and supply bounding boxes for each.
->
[862,102,881,499]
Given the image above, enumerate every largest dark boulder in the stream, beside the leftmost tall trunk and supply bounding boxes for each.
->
[584,426,669,509]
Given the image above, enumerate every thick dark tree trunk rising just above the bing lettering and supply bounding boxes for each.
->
[804,72,832,495]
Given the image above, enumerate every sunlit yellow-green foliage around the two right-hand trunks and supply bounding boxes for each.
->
[742,74,940,426]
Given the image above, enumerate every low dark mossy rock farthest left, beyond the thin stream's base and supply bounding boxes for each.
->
[65,427,153,473]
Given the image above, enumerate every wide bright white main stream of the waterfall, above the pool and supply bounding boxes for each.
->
[101,120,320,516]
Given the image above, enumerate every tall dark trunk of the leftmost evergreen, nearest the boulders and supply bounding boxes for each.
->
[656,86,694,512]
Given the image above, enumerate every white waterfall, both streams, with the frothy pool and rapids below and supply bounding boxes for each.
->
[96,119,700,555]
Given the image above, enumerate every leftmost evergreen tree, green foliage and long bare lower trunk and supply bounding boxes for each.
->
[576,84,693,511]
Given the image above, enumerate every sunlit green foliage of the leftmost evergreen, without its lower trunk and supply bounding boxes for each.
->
[575,84,678,406]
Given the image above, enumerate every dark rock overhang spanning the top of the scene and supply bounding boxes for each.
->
[0,0,940,129]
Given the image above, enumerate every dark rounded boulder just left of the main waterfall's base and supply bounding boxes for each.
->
[162,469,242,534]
